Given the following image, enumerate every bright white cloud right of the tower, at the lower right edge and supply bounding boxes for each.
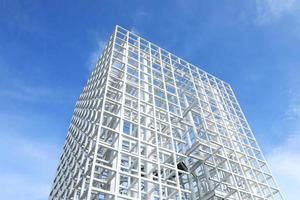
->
[266,92,300,200]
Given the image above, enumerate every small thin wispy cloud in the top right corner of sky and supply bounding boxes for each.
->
[255,0,297,25]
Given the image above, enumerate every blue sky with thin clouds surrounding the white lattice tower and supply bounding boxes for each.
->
[0,0,300,200]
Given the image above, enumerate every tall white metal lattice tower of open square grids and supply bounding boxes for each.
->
[49,26,283,200]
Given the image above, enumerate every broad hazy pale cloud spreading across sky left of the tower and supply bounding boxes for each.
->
[0,55,68,200]
